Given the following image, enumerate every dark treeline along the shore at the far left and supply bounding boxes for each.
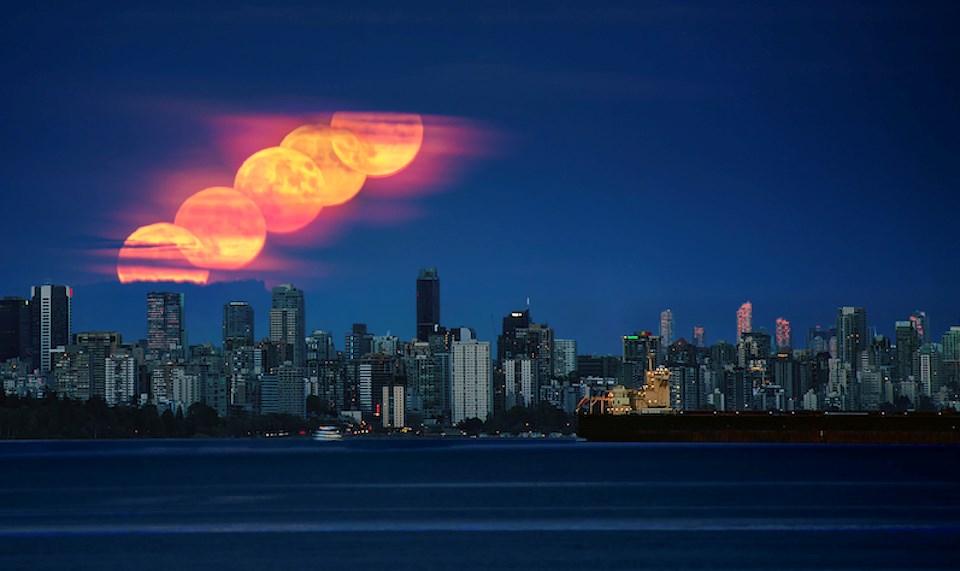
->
[0,391,316,439]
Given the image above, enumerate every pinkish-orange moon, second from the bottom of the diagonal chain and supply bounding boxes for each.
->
[173,186,267,270]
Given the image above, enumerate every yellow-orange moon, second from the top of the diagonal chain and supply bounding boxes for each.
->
[280,125,367,206]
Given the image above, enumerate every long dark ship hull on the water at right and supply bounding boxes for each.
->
[577,413,960,445]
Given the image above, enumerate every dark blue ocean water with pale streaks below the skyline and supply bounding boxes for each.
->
[0,439,960,571]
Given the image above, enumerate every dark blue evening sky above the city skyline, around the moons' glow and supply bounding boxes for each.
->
[0,1,960,353]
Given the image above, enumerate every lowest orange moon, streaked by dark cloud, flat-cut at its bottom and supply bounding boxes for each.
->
[117,222,210,284]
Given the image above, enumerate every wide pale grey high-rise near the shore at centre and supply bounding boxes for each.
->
[450,330,493,424]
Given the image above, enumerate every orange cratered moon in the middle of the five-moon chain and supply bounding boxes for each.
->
[233,147,326,234]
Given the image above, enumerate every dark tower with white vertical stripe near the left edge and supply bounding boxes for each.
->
[30,284,73,373]
